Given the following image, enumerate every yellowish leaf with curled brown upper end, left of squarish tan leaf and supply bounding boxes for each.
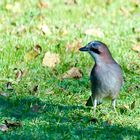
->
[24,45,42,62]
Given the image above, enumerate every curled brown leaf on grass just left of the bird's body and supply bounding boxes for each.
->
[62,67,82,79]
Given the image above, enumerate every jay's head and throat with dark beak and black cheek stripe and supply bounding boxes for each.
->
[79,41,114,63]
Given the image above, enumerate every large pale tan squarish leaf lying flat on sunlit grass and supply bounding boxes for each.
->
[42,52,60,68]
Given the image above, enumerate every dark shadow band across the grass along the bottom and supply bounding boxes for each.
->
[0,97,140,139]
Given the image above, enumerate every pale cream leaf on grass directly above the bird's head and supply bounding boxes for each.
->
[85,28,104,37]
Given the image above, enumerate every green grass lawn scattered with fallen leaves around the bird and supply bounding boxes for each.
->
[0,0,140,140]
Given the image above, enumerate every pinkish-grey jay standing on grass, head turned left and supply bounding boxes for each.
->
[79,41,123,111]
